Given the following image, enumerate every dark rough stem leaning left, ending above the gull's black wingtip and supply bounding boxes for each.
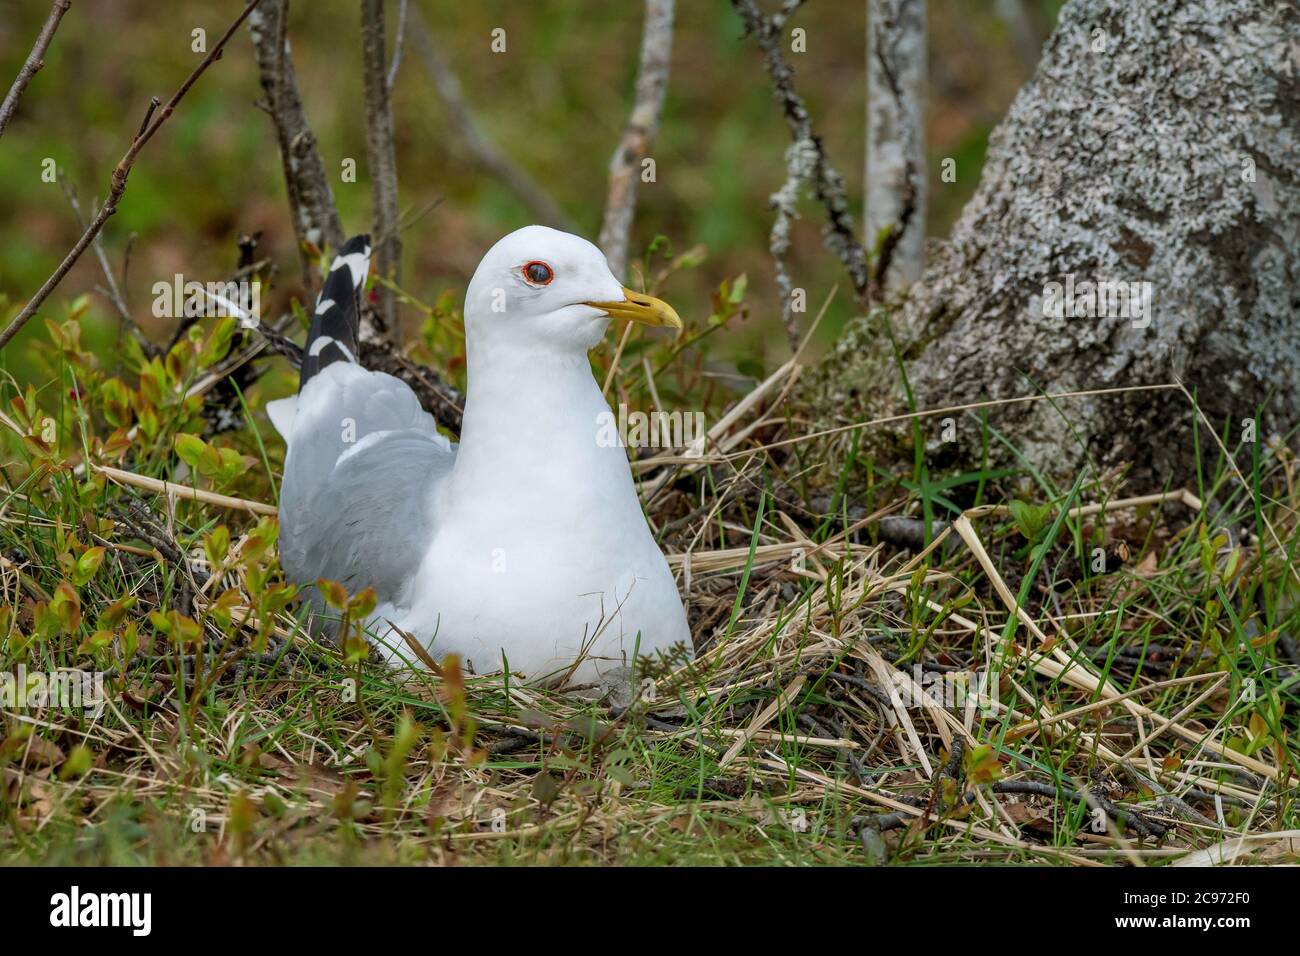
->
[248,0,343,291]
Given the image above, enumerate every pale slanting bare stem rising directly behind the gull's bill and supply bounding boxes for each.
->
[597,0,673,277]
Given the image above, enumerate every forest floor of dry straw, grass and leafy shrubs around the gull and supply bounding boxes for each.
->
[0,297,1300,866]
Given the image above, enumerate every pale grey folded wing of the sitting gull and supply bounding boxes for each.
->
[270,362,455,605]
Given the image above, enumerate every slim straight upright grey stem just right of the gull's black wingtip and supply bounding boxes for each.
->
[361,0,402,342]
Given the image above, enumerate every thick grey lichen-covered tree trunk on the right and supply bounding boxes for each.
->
[813,0,1300,486]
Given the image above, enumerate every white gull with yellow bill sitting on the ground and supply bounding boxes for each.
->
[267,225,692,687]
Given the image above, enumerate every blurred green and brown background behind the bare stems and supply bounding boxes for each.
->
[0,0,1060,378]
